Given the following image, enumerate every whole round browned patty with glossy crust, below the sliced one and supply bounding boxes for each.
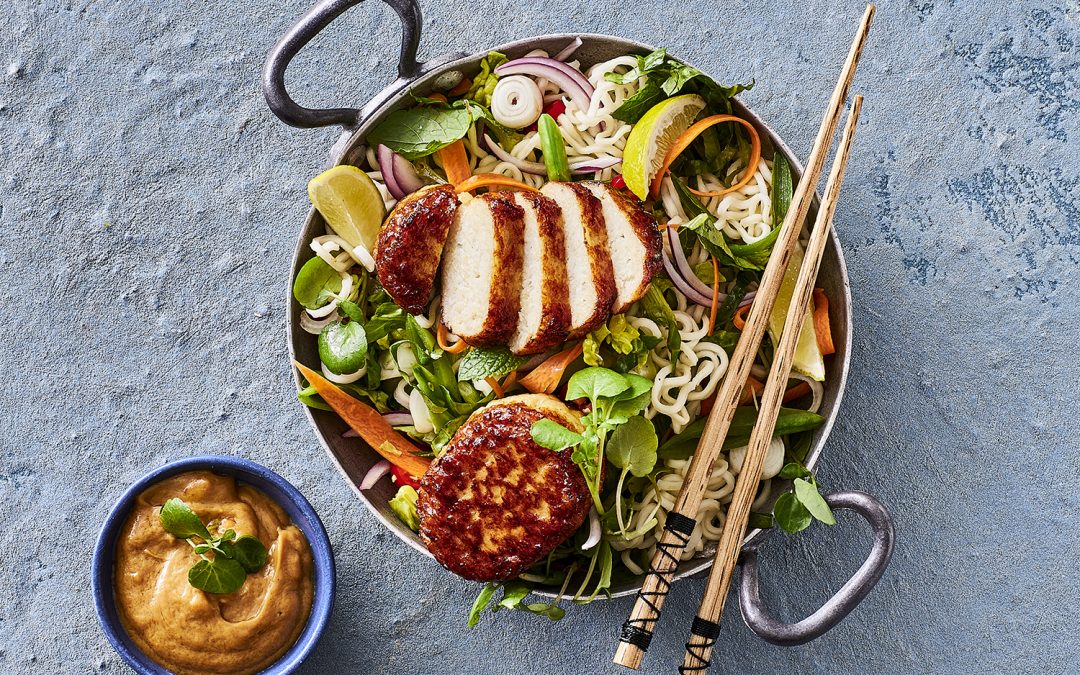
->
[417,395,592,581]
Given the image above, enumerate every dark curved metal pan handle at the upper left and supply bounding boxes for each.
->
[262,0,423,129]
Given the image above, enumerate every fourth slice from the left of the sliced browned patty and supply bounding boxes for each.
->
[540,183,616,337]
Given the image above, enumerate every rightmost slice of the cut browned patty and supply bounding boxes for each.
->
[581,181,663,314]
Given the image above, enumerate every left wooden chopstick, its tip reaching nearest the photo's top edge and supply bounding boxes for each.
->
[613,4,874,670]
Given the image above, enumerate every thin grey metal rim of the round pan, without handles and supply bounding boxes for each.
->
[285,32,853,598]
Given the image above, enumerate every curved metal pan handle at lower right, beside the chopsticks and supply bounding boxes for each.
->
[739,491,895,646]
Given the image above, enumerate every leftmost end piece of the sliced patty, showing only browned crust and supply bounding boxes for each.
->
[375,181,460,314]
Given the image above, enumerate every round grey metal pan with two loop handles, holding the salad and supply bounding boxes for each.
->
[262,0,893,645]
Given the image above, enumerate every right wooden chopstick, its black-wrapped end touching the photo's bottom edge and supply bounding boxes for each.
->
[679,96,863,674]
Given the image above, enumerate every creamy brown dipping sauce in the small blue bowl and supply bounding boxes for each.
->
[113,471,314,675]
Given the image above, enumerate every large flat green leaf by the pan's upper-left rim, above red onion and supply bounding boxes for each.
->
[367,106,475,160]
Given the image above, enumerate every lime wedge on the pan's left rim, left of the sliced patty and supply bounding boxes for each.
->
[308,164,387,252]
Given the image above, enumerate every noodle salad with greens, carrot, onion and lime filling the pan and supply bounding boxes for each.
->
[294,41,833,625]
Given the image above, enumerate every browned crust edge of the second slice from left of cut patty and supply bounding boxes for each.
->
[465,192,525,347]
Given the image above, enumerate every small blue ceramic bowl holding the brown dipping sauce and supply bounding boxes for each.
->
[91,455,335,675]
